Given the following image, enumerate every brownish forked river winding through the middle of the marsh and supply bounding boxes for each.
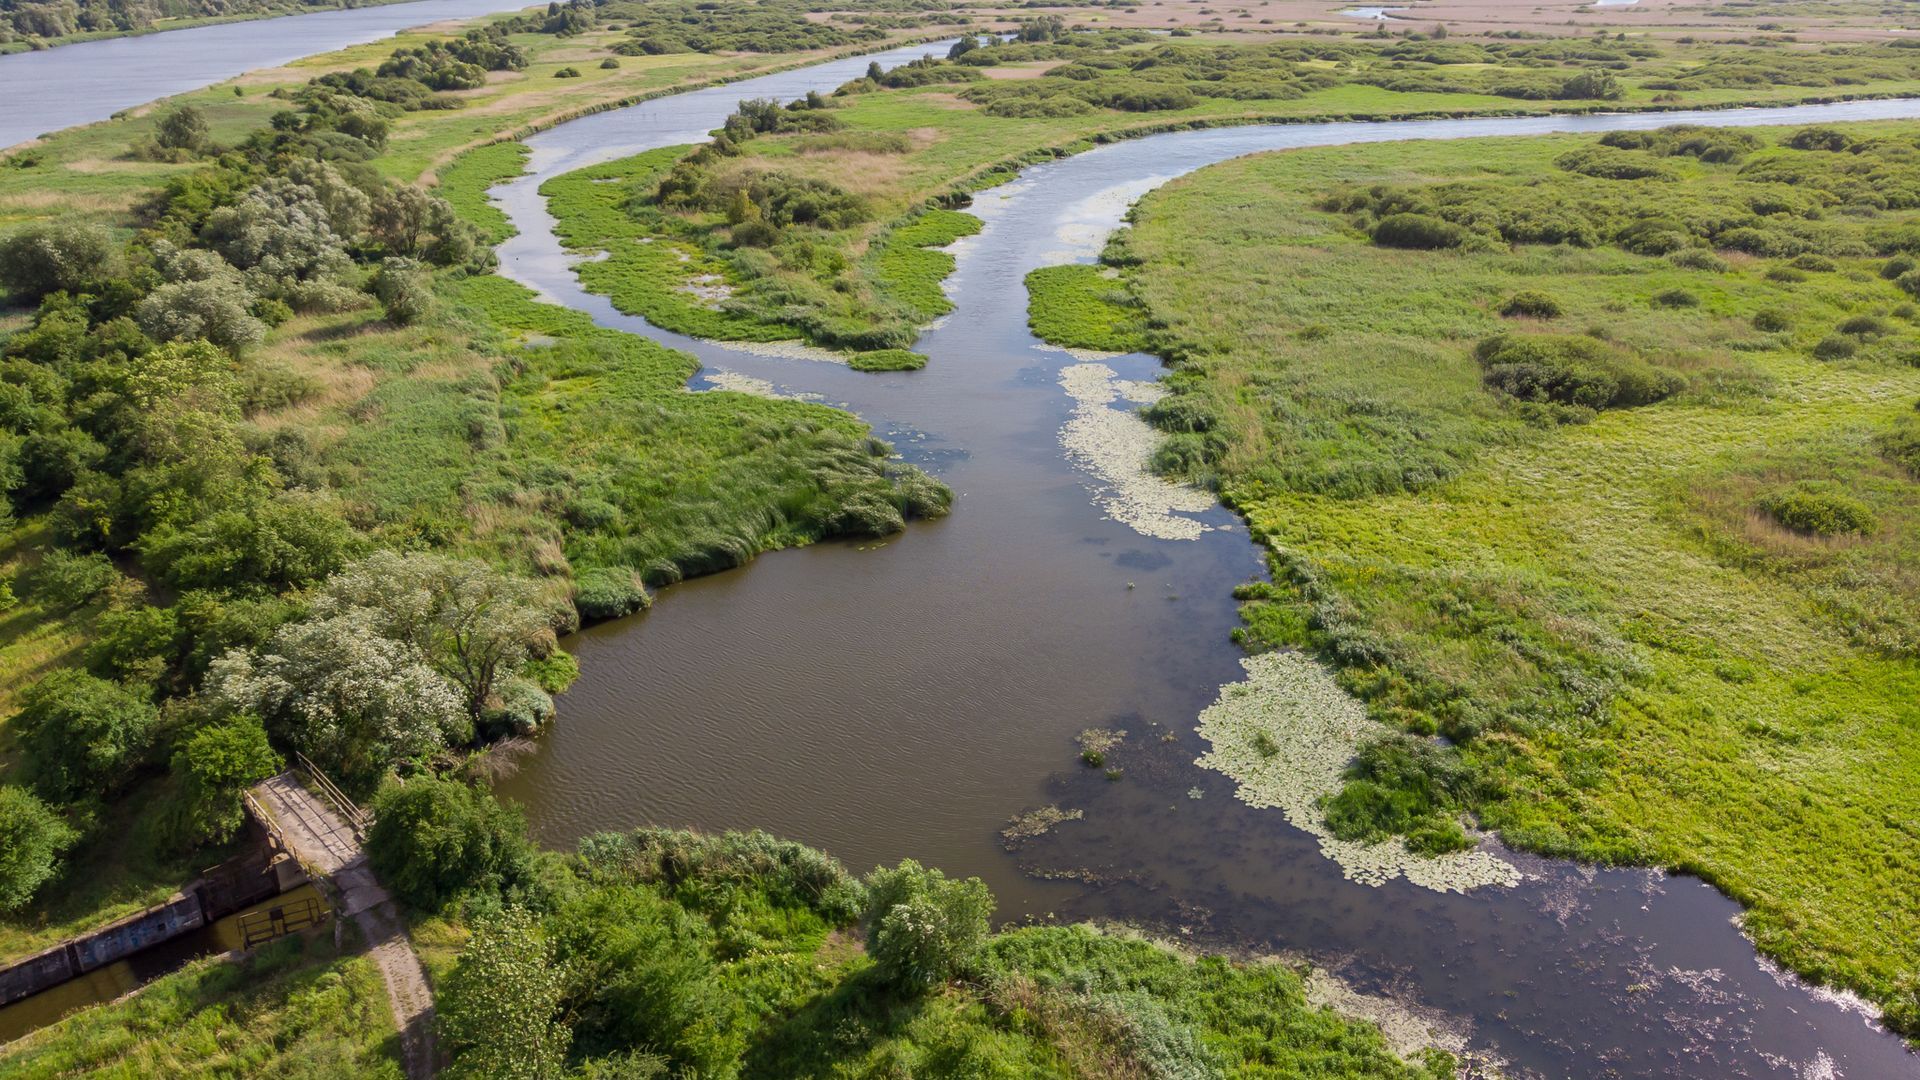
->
[493,48,1920,1080]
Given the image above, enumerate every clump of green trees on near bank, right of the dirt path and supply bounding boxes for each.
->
[355,778,993,1078]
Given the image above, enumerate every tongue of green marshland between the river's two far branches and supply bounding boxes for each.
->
[547,31,1920,352]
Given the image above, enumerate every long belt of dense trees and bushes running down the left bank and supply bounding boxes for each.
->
[0,16,574,909]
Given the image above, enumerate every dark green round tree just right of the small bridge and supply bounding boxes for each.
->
[367,776,532,911]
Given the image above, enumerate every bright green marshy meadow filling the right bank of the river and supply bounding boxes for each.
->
[1064,125,1920,1032]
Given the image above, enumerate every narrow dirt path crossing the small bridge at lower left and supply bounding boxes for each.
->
[253,773,434,1080]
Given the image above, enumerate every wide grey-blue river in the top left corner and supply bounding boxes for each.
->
[0,0,541,146]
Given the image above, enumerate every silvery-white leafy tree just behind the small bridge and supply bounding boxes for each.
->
[207,609,472,780]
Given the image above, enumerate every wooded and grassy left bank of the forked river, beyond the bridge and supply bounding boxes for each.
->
[0,6,947,1006]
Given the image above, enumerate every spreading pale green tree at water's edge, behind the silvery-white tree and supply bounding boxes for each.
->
[313,552,553,717]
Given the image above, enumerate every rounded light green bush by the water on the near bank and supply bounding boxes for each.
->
[866,859,993,990]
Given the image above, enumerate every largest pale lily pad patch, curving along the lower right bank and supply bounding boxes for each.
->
[1196,653,1521,892]
